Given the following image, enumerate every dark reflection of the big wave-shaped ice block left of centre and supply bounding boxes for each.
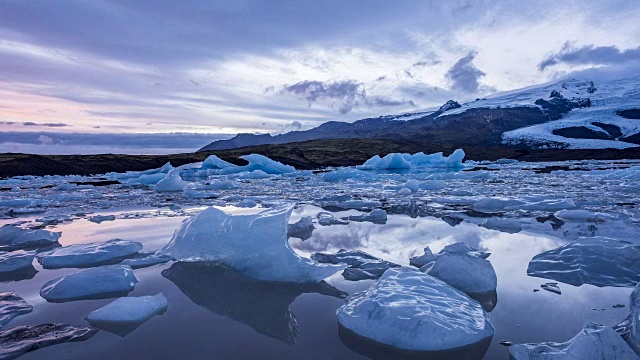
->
[162,262,347,344]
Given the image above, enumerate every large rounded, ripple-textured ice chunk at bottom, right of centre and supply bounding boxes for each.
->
[336,267,494,351]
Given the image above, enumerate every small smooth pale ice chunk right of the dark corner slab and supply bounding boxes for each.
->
[86,293,169,336]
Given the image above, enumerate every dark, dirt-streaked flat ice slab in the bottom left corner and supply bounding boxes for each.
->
[0,324,98,359]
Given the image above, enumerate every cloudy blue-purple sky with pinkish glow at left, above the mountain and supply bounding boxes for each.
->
[0,0,640,153]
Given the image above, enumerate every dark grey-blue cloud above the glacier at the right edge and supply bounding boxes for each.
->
[538,43,640,71]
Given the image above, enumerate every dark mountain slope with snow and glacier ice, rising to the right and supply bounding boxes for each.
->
[201,76,640,151]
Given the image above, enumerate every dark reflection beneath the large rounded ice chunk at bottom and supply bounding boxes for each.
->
[338,324,492,360]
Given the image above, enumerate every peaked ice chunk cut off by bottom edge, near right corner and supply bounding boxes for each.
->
[509,323,638,360]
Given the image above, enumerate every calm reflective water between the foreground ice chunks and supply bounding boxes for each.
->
[0,205,631,359]
